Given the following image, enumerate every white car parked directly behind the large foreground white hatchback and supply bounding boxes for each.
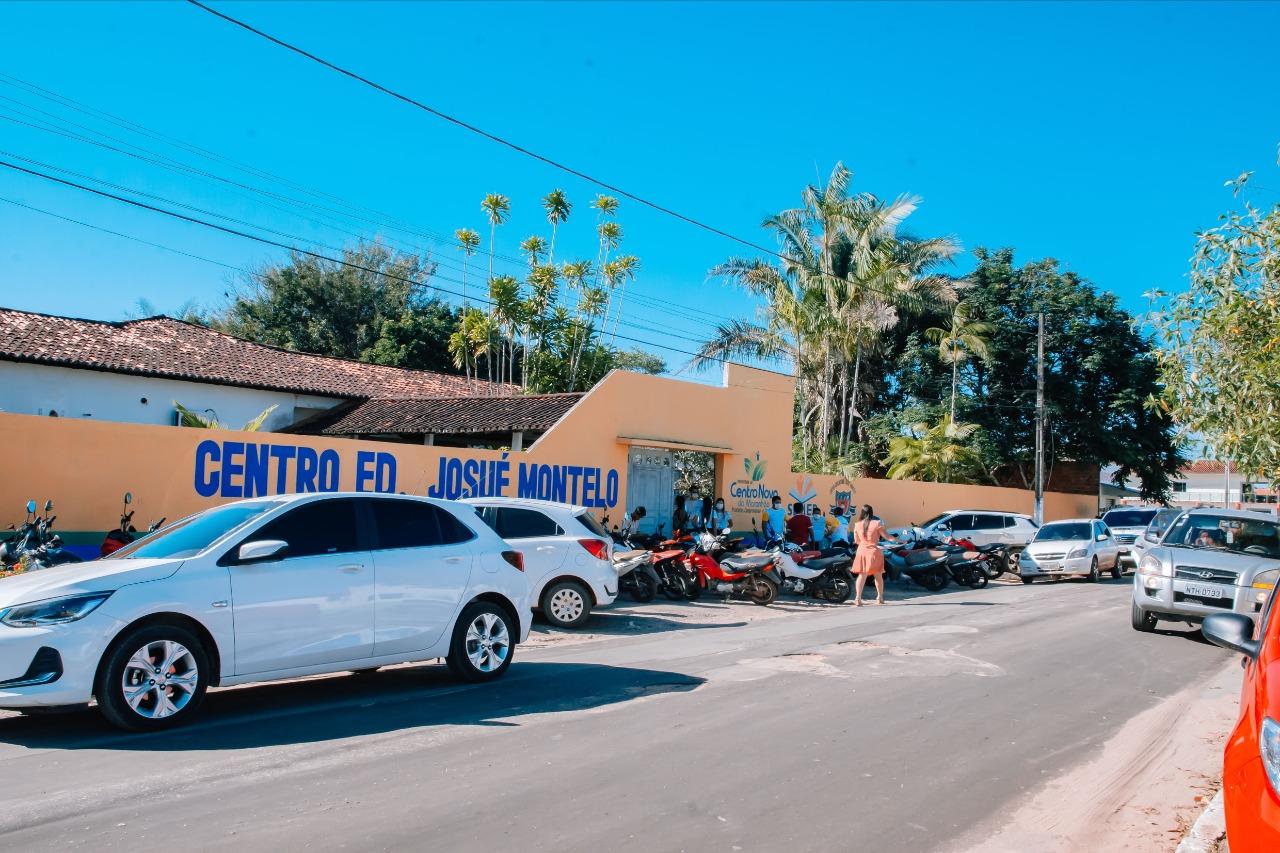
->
[462,497,618,628]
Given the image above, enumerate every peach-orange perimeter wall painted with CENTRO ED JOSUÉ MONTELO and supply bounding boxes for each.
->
[0,365,1096,532]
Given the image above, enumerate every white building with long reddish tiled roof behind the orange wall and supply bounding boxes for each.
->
[0,309,509,430]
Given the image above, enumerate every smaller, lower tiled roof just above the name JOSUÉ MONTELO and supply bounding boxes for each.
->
[284,393,582,435]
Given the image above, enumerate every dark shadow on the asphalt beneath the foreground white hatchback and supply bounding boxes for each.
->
[0,662,704,752]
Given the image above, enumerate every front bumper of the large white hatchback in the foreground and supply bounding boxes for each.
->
[0,612,123,708]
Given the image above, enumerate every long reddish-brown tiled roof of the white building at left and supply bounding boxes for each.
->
[0,309,515,397]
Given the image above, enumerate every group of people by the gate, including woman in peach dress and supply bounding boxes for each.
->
[622,494,897,607]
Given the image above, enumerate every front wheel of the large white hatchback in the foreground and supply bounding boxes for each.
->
[93,625,212,731]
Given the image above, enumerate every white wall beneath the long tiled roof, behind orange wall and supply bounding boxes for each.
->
[0,361,338,430]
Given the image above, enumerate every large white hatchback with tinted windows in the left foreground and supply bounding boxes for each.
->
[0,493,531,731]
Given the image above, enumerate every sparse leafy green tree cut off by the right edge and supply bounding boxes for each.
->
[1148,194,1280,479]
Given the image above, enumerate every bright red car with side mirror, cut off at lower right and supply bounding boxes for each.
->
[1203,592,1280,853]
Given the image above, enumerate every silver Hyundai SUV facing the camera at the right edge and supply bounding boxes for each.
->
[1133,510,1280,631]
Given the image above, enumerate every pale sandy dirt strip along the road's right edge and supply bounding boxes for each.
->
[954,661,1240,853]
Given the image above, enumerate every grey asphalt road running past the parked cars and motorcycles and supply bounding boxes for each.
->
[0,573,1230,853]
